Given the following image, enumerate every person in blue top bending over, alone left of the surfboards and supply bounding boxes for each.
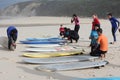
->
[7,26,18,50]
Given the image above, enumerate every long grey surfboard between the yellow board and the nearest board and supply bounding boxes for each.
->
[23,55,98,64]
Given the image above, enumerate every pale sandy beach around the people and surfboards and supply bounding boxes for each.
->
[0,17,120,80]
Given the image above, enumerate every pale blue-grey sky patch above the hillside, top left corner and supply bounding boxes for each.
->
[0,0,31,9]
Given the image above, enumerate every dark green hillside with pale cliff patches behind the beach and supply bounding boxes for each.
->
[0,0,120,18]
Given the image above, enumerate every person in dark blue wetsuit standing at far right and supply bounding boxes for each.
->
[107,13,120,44]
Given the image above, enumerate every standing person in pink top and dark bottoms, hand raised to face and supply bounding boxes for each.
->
[71,14,80,33]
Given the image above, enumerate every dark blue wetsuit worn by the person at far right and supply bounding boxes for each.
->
[109,17,120,42]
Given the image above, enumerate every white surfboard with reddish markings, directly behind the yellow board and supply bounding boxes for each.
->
[25,46,74,52]
